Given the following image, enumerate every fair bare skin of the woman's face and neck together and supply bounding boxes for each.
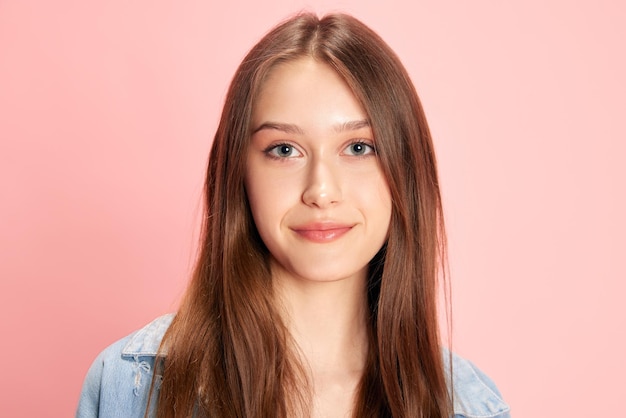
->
[245,58,391,417]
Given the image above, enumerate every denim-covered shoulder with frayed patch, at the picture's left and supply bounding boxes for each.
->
[76,314,174,418]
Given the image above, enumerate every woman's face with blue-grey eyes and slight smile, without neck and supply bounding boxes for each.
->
[245,58,391,281]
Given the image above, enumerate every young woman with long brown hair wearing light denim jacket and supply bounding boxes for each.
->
[77,14,509,418]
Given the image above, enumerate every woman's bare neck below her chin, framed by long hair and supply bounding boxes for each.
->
[273,272,368,418]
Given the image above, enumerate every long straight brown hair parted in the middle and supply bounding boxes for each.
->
[153,14,451,418]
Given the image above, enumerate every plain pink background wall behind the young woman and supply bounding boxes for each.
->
[0,0,626,418]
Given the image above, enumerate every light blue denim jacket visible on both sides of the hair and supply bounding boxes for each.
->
[76,314,510,418]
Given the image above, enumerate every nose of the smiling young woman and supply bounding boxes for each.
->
[302,161,342,209]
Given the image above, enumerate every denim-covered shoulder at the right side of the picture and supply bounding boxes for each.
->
[444,351,510,418]
